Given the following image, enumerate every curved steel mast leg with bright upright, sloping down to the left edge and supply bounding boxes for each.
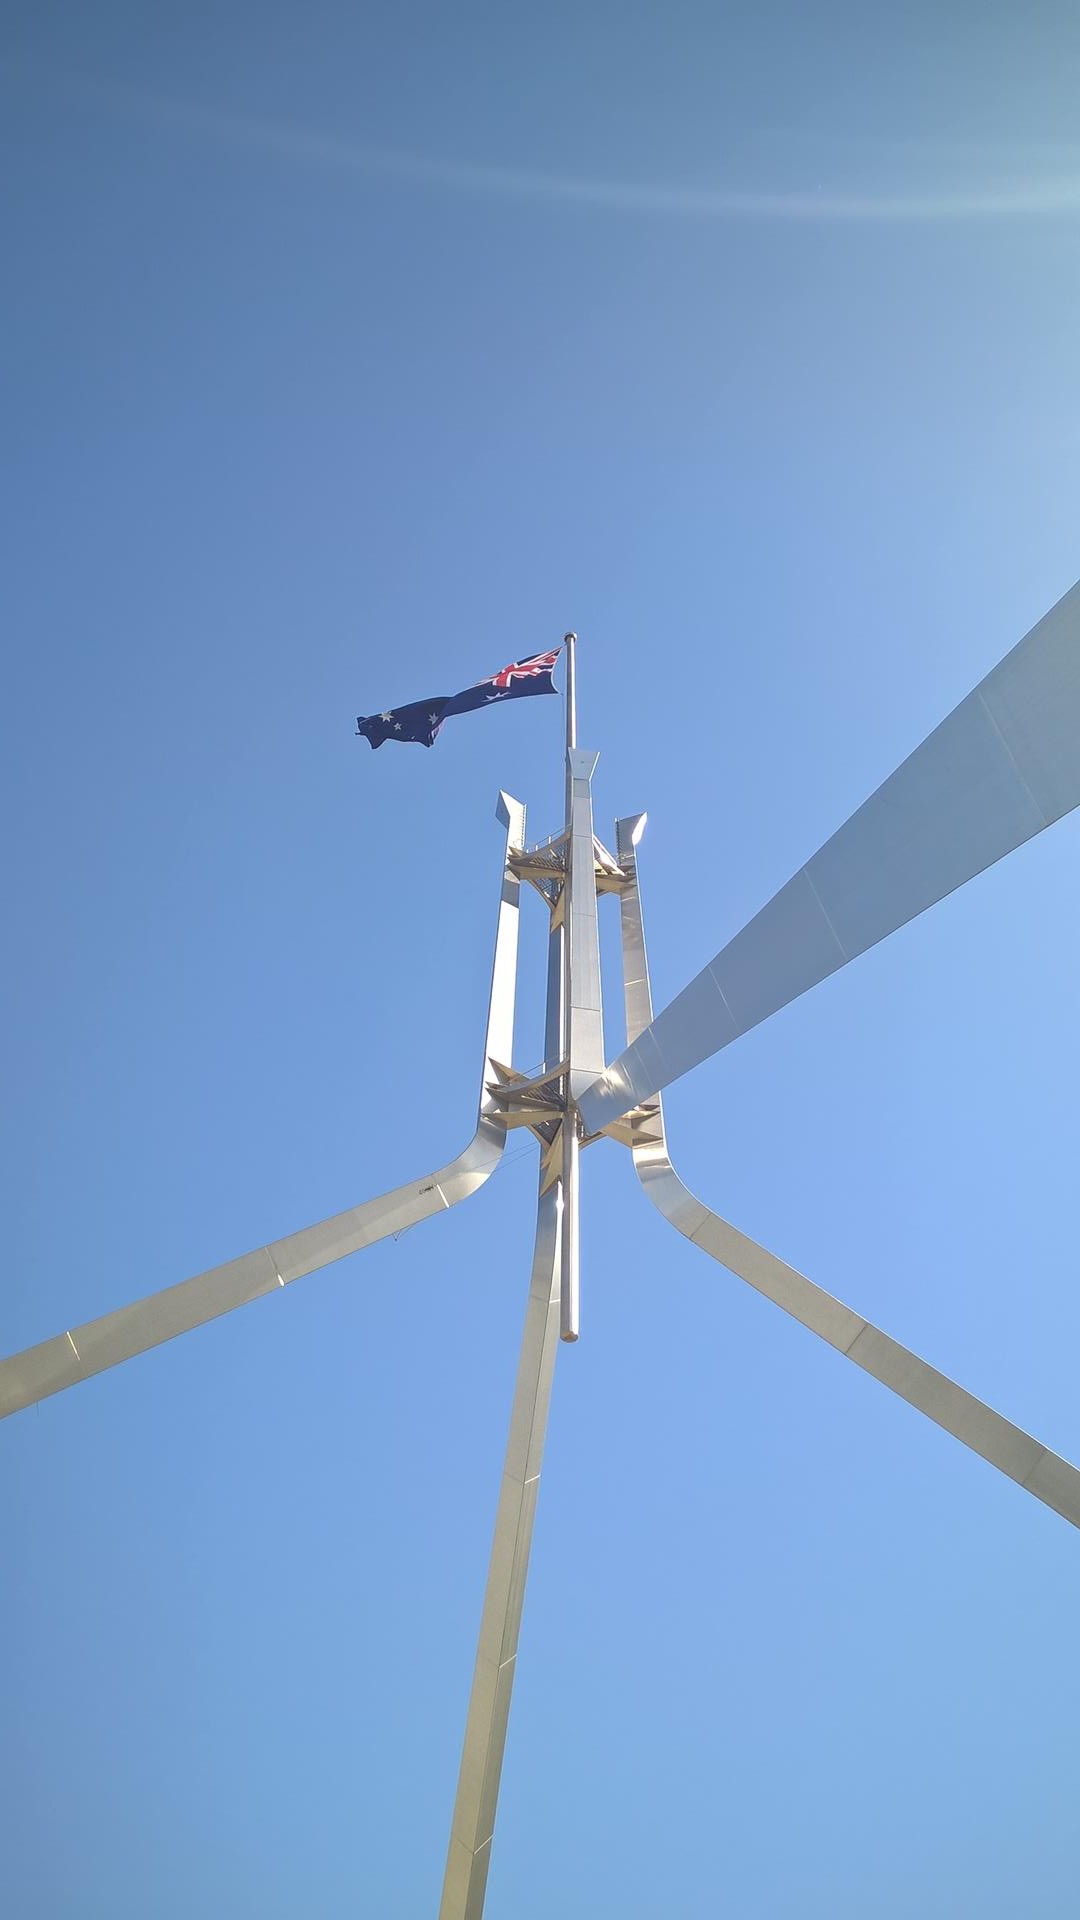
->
[0,793,525,1419]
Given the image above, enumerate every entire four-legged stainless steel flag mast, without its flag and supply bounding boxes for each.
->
[0,584,1080,1920]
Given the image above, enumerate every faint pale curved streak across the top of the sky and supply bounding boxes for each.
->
[12,60,1080,223]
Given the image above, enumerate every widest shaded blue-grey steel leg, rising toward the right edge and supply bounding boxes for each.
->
[578,584,1080,1133]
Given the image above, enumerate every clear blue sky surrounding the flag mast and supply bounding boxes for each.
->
[0,0,1080,1920]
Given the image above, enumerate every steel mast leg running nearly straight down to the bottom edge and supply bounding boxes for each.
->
[438,890,565,1920]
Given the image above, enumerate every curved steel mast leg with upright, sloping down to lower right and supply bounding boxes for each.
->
[617,816,1080,1526]
